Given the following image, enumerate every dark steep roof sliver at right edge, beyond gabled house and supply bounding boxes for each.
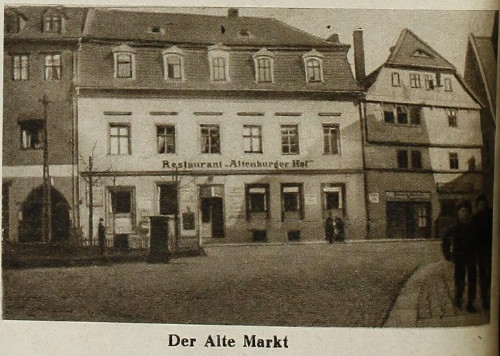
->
[469,34,497,113]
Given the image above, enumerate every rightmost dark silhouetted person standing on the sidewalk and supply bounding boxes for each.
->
[473,195,493,309]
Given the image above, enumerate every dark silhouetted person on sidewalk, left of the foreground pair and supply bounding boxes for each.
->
[442,202,477,313]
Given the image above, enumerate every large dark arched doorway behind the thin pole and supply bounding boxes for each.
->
[19,187,70,242]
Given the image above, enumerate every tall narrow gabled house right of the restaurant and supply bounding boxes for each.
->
[363,30,482,238]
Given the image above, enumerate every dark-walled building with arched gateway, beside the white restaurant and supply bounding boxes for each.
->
[2,6,86,242]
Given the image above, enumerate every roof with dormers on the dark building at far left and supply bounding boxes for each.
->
[5,6,88,40]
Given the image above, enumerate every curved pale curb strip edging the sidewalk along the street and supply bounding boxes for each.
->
[384,261,444,328]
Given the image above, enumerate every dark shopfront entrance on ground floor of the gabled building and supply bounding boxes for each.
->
[387,201,431,239]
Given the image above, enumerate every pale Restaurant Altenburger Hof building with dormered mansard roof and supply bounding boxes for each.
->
[77,10,366,247]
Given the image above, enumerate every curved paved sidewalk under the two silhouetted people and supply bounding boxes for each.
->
[384,260,489,327]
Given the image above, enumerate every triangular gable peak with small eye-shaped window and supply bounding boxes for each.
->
[386,29,456,71]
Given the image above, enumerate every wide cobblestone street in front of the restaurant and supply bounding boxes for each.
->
[3,241,446,326]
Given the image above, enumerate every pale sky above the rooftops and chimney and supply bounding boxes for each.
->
[115,8,494,74]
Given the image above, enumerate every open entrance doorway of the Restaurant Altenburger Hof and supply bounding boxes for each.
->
[200,186,224,238]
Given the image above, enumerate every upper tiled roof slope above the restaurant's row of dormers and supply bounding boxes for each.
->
[84,9,345,48]
